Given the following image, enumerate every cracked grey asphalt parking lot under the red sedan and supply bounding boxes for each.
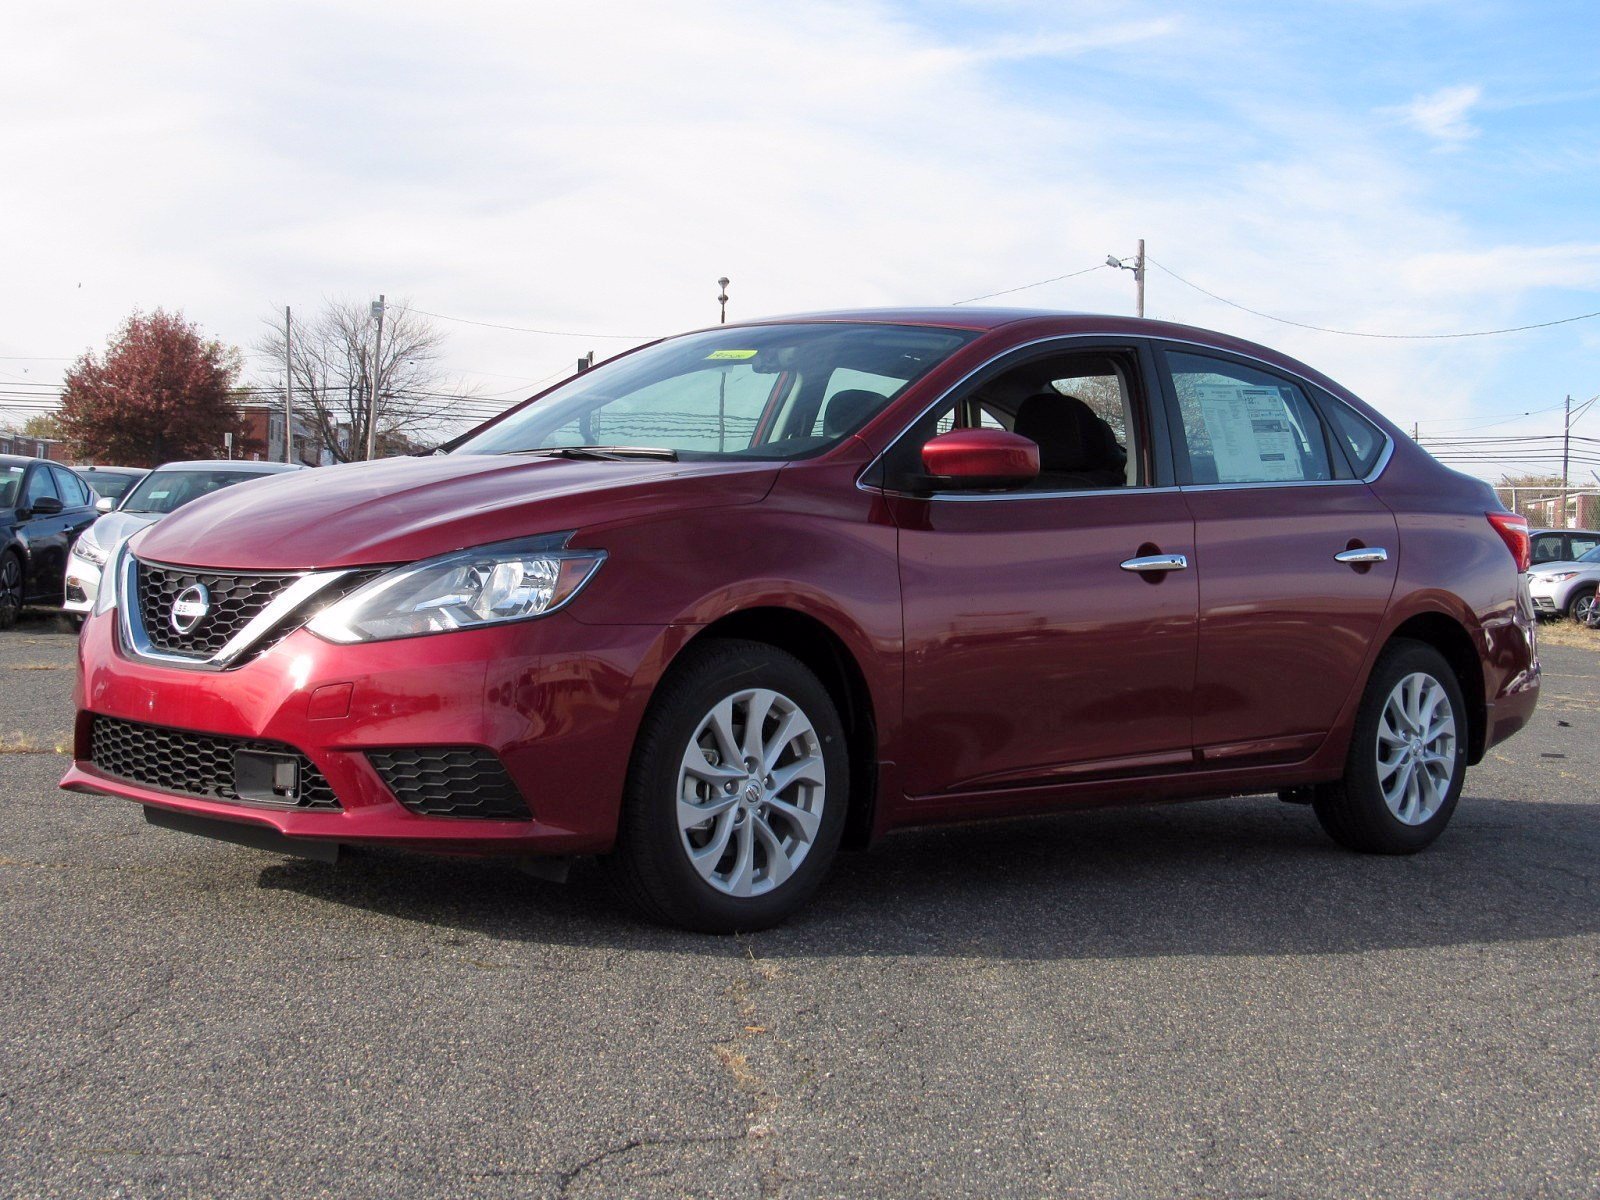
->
[0,618,1600,1198]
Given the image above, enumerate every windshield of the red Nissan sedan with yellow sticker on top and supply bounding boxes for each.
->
[454,323,976,459]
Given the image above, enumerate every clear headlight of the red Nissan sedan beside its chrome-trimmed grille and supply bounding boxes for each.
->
[306,533,605,643]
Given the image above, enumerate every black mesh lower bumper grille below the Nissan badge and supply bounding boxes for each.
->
[90,715,339,808]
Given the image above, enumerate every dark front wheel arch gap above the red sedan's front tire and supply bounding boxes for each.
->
[667,605,878,848]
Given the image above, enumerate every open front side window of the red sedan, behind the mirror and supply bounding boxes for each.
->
[890,350,1144,491]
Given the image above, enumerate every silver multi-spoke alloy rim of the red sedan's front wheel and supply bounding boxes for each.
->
[677,688,827,898]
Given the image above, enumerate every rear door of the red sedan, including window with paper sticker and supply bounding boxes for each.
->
[1160,344,1398,766]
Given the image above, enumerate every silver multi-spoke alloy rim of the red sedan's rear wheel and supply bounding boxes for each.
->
[1378,672,1456,826]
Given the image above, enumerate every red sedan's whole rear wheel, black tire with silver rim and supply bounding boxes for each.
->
[1312,640,1469,854]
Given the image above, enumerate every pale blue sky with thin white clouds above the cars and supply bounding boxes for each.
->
[0,0,1600,482]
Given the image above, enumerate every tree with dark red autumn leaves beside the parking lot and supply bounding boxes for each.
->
[61,309,243,467]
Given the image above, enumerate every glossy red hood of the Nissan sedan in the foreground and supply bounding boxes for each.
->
[134,454,779,571]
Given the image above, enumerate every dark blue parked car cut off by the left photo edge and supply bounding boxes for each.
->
[0,454,96,629]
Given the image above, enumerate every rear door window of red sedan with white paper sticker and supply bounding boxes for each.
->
[1166,352,1333,483]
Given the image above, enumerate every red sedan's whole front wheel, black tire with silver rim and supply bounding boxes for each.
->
[605,638,850,933]
